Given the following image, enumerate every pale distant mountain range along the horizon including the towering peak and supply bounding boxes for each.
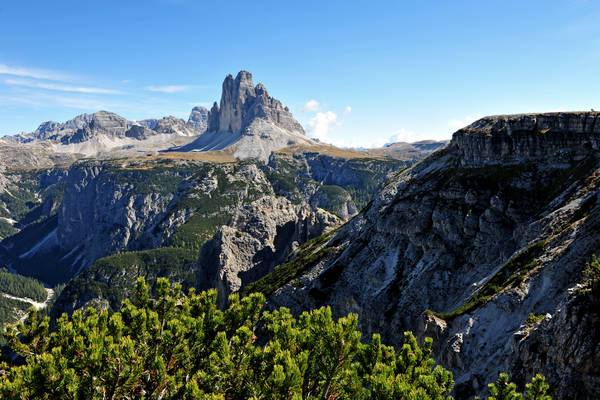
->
[0,71,445,166]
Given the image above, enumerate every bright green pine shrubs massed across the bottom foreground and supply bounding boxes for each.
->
[0,279,453,400]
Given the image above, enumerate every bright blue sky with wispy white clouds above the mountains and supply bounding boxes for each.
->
[0,0,600,147]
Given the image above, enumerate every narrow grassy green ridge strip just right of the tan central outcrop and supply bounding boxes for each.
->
[242,228,339,297]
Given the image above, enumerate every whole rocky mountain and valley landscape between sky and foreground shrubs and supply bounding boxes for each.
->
[0,71,600,399]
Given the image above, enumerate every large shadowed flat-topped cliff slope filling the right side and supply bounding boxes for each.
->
[269,113,600,398]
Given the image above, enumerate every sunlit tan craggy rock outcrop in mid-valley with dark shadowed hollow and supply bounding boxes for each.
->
[198,196,341,306]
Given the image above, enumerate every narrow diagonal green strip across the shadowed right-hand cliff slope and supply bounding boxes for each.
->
[433,240,546,319]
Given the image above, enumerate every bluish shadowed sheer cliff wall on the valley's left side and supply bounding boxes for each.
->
[57,163,177,273]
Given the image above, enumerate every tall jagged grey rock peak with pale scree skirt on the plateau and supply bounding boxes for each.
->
[182,71,314,162]
